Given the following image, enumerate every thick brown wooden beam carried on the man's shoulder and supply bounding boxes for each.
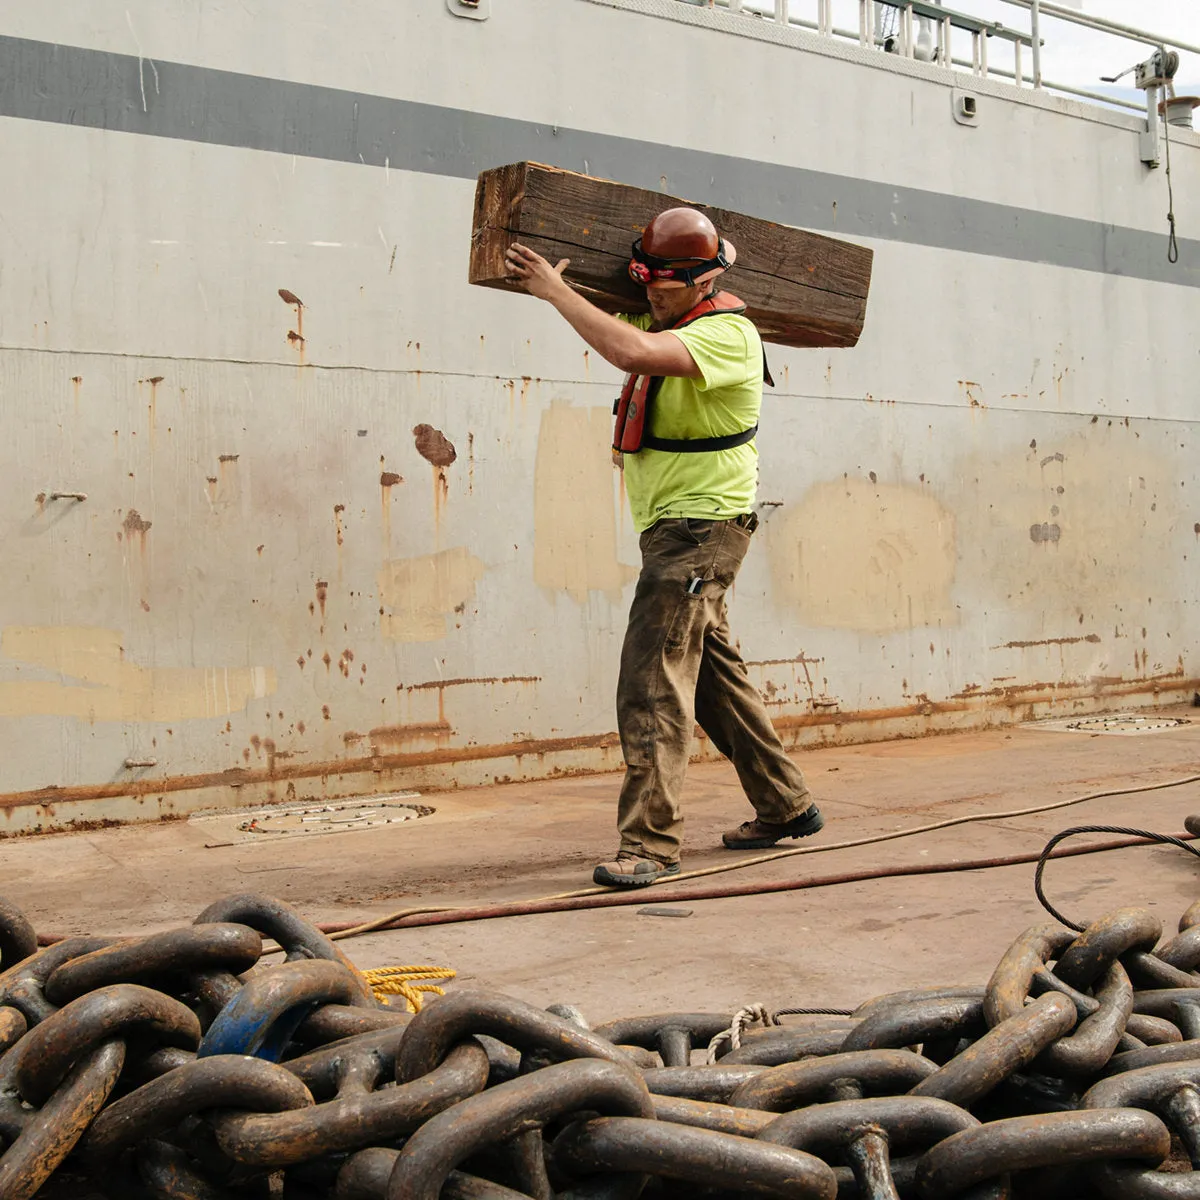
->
[469,162,874,347]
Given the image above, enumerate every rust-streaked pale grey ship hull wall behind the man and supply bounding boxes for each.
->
[0,0,1198,833]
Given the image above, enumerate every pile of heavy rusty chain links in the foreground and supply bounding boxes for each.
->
[7,896,1200,1200]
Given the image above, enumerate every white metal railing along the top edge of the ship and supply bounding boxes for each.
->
[680,0,1200,113]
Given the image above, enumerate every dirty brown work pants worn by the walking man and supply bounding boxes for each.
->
[617,517,811,863]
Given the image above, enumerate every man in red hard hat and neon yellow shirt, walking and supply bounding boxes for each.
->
[508,209,823,887]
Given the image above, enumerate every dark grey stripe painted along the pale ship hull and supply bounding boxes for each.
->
[0,36,1200,287]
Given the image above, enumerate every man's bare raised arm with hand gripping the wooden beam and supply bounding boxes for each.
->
[506,244,701,379]
